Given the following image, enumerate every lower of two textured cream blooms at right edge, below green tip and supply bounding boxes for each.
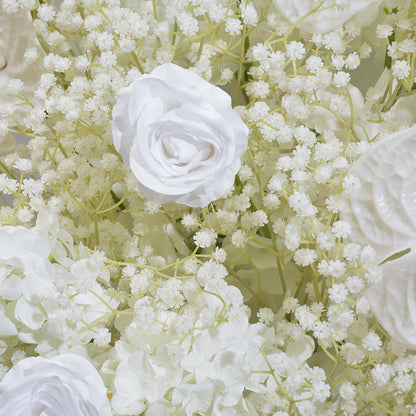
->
[366,253,416,350]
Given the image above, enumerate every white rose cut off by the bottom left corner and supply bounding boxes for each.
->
[0,354,111,416]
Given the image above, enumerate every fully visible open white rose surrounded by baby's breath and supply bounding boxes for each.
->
[113,64,248,207]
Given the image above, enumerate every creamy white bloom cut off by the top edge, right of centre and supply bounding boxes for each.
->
[273,0,381,33]
